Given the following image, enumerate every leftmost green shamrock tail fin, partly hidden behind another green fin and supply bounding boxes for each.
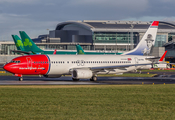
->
[12,35,25,51]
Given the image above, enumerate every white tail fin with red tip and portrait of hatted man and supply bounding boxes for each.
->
[123,21,159,55]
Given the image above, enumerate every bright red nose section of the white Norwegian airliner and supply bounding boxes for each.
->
[4,55,49,75]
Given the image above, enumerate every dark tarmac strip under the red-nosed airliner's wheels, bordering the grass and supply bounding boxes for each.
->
[0,76,175,85]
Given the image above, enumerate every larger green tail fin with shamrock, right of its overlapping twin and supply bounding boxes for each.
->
[19,31,43,52]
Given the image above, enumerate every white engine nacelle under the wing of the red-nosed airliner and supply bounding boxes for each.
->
[72,69,93,79]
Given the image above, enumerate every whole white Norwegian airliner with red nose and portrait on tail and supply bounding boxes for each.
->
[4,21,161,81]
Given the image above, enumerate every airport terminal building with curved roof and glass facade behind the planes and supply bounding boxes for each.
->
[0,20,175,62]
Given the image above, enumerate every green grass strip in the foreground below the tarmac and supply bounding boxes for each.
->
[0,84,175,120]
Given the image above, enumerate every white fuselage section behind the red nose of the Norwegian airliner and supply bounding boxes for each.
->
[47,55,151,75]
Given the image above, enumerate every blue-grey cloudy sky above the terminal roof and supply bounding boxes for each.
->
[0,0,175,41]
